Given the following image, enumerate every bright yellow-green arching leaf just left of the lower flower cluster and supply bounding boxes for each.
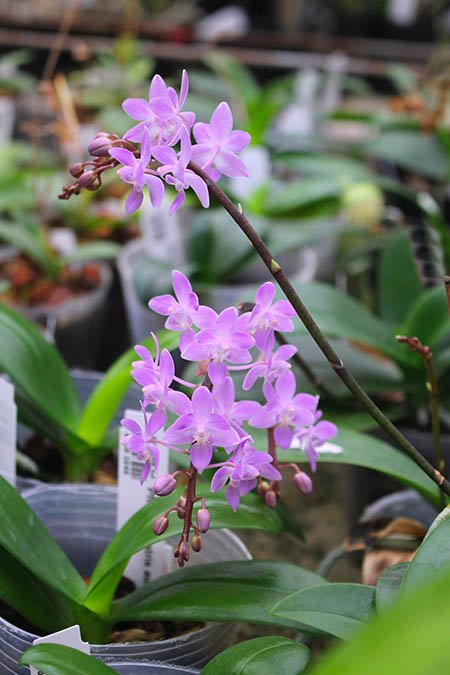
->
[77,331,179,446]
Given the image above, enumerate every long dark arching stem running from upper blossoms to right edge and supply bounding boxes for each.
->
[189,162,450,497]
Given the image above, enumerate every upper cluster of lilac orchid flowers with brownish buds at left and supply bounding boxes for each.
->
[60,70,250,214]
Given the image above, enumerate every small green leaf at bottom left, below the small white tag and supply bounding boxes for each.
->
[19,644,118,675]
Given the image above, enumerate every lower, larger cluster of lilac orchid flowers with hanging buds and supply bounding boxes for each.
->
[122,271,337,564]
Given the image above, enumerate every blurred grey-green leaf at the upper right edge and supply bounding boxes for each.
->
[366,130,449,181]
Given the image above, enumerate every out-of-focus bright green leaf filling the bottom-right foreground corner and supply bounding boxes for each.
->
[310,569,450,675]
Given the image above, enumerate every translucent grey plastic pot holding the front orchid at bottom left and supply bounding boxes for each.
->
[0,484,251,675]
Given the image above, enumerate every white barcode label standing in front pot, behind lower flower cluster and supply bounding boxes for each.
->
[117,410,173,586]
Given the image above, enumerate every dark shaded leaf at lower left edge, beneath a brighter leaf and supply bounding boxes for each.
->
[0,547,76,633]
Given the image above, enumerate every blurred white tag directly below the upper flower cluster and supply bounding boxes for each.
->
[139,199,183,264]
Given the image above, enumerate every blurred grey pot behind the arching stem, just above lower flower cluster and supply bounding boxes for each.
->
[200,247,319,312]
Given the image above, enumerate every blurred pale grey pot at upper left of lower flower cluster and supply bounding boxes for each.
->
[117,239,164,344]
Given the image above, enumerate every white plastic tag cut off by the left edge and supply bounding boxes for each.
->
[0,377,17,485]
